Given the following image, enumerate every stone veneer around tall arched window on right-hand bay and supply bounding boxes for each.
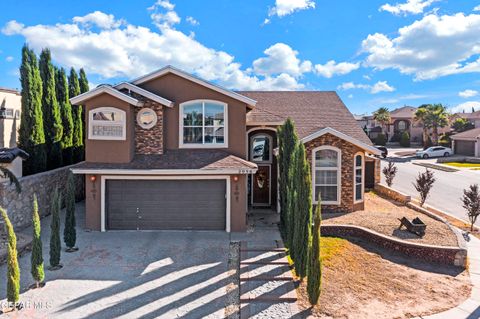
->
[305,134,365,212]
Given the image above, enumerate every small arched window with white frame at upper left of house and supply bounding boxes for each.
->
[88,107,127,140]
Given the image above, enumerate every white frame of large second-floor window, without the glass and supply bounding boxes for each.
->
[178,99,228,148]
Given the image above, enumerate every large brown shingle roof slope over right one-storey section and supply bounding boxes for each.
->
[238,91,372,145]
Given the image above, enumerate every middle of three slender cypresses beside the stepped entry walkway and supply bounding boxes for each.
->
[292,143,312,278]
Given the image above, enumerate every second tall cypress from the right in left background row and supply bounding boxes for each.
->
[55,68,73,165]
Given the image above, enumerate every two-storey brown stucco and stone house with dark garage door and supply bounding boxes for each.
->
[71,67,379,231]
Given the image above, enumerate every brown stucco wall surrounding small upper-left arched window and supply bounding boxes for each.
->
[85,93,135,163]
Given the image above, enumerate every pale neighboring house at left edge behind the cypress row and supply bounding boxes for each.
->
[0,88,22,148]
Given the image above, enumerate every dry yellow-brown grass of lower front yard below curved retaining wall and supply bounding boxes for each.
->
[298,237,471,319]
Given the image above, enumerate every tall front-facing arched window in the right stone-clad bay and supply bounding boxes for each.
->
[312,146,342,205]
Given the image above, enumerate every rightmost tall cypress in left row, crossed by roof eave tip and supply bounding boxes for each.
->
[68,68,83,163]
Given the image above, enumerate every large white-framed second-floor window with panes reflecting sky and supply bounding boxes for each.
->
[180,100,227,148]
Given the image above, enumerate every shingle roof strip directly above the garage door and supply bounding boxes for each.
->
[74,150,257,170]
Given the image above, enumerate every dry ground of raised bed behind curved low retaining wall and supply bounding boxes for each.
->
[323,192,458,246]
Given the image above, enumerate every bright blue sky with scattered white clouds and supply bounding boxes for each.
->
[0,0,480,114]
